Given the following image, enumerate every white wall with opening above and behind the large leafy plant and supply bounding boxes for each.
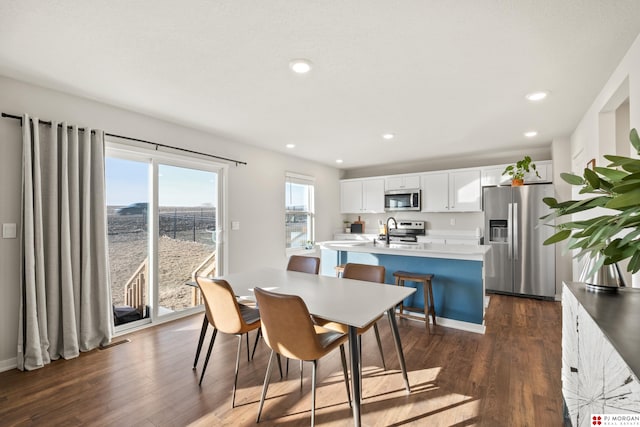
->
[571,36,640,280]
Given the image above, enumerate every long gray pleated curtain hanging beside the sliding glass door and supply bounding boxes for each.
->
[18,115,113,370]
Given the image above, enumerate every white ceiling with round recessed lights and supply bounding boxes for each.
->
[0,0,640,169]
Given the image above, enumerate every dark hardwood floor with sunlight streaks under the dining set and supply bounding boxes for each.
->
[0,295,562,426]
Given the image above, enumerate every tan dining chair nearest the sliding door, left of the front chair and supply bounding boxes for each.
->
[196,277,261,408]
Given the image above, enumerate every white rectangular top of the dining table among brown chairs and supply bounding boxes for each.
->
[220,268,415,328]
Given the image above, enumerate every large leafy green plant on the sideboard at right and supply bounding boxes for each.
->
[542,129,640,276]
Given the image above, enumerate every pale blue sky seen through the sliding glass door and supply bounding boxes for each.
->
[105,157,217,207]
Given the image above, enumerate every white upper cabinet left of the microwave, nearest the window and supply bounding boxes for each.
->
[340,178,384,213]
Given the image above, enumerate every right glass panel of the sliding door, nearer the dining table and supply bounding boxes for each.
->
[157,164,218,316]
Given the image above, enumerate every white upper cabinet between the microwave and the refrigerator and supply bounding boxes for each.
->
[422,169,481,212]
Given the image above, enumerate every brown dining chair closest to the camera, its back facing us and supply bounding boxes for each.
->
[254,288,351,426]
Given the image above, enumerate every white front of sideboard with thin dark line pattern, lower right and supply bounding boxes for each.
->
[561,286,640,426]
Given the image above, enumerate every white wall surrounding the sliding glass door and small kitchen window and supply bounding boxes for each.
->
[0,77,342,371]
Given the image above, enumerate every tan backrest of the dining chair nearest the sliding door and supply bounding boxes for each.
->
[196,277,246,334]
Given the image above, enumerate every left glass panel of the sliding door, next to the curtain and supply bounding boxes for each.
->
[105,157,150,326]
